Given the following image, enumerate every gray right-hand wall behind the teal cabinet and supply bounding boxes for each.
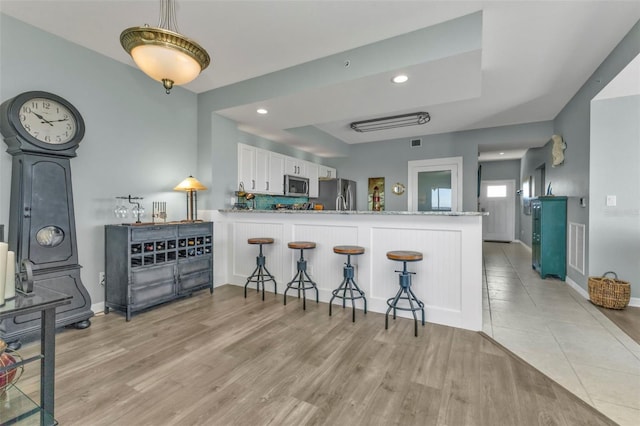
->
[521,17,640,291]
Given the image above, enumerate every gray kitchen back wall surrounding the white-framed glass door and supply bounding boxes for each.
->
[329,121,553,211]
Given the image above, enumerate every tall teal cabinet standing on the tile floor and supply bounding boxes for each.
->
[531,197,567,281]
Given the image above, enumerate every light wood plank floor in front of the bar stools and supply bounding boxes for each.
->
[16,286,614,426]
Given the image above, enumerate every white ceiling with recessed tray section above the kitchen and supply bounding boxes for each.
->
[0,0,640,158]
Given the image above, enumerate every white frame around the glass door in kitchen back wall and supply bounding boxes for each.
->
[407,157,464,212]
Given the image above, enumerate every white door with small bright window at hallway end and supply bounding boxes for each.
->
[478,180,516,241]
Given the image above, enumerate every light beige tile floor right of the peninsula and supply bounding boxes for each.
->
[483,243,640,426]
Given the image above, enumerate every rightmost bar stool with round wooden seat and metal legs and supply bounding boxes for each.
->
[384,250,424,337]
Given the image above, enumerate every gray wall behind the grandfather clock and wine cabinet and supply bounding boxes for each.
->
[0,14,198,304]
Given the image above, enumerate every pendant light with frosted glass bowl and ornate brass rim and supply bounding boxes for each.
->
[120,0,211,94]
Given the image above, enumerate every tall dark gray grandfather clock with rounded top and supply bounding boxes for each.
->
[0,91,93,341]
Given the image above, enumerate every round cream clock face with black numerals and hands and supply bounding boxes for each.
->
[19,97,78,145]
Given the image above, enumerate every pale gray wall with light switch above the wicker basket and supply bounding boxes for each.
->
[589,95,640,297]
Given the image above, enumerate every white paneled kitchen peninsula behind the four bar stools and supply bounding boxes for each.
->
[207,210,483,330]
